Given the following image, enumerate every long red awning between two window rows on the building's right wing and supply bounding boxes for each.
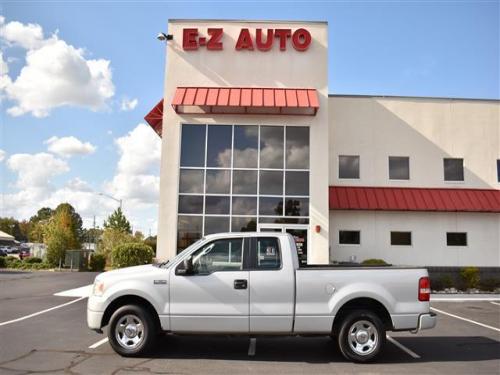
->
[329,186,500,213]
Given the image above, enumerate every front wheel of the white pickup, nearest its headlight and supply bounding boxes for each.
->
[108,305,159,357]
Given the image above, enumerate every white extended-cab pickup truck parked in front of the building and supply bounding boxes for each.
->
[87,233,436,362]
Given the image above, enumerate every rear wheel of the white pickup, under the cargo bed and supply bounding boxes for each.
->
[337,310,386,363]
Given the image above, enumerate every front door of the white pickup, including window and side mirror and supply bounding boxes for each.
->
[170,238,249,333]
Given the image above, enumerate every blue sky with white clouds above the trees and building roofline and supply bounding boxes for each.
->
[0,0,500,235]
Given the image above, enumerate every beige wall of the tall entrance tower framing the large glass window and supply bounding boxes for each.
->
[157,20,329,263]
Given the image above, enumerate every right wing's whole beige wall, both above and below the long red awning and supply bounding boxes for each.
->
[329,96,500,267]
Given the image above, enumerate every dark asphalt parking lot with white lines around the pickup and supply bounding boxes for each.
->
[0,271,500,374]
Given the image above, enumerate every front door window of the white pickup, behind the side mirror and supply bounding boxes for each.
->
[192,238,243,275]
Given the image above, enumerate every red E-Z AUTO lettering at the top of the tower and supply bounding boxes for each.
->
[182,27,311,52]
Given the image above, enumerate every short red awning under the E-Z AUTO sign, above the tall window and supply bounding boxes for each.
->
[172,87,319,116]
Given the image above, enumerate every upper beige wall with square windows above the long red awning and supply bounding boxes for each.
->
[329,96,500,189]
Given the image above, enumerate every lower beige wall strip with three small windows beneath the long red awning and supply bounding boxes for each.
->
[330,211,500,267]
